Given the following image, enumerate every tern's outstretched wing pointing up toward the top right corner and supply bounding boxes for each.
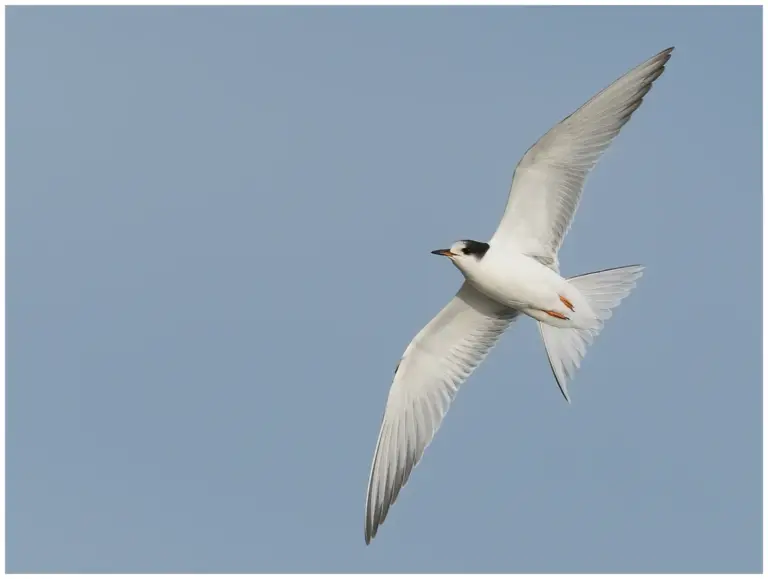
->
[491,48,673,262]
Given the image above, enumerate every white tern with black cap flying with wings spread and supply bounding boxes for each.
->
[365,48,673,543]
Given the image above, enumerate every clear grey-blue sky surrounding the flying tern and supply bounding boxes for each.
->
[6,7,762,572]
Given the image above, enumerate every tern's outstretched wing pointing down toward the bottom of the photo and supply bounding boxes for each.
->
[365,282,517,543]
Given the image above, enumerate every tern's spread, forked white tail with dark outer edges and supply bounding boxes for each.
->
[539,265,643,402]
